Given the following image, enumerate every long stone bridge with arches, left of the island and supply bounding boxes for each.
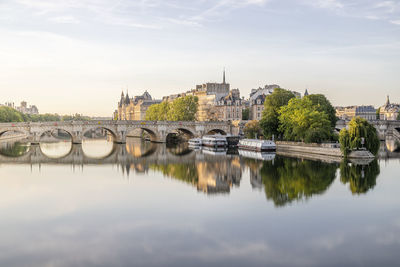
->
[0,120,234,144]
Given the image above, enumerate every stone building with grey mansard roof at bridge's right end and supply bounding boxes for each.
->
[215,89,246,121]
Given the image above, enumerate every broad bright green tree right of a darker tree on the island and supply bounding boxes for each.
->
[279,98,332,143]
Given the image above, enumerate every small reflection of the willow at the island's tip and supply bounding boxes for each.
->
[340,159,380,194]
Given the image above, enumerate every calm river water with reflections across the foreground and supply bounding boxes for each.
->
[0,139,400,267]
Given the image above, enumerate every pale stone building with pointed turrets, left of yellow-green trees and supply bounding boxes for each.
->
[114,91,161,121]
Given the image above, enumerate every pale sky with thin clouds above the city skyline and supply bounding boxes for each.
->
[0,0,400,116]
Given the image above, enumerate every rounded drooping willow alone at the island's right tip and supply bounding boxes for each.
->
[339,117,380,156]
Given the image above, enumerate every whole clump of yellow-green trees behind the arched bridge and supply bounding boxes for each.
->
[146,96,198,121]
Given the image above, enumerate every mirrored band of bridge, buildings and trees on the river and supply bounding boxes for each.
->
[0,139,390,200]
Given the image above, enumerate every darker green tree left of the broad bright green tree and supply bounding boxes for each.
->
[260,88,295,138]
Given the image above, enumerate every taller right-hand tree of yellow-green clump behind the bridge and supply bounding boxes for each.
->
[167,95,199,121]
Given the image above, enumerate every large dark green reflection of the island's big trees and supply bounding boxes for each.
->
[261,156,337,206]
